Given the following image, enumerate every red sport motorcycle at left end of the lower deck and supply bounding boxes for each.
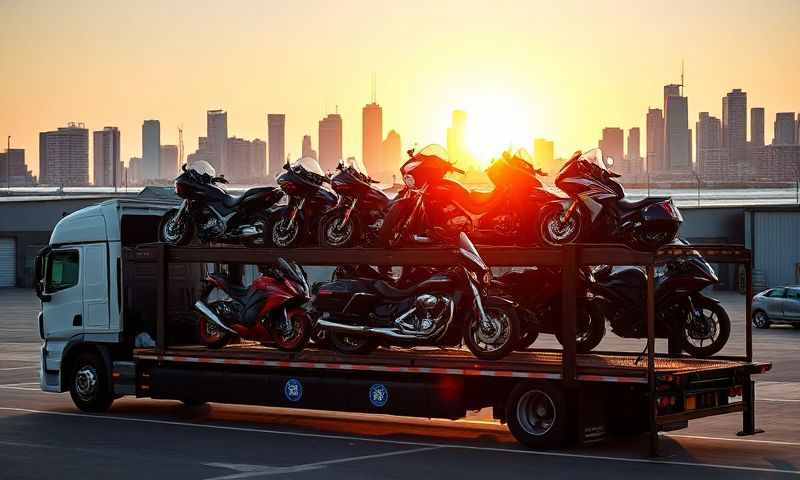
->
[194,258,312,351]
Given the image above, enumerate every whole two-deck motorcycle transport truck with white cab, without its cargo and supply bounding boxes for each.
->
[36,199,771,455]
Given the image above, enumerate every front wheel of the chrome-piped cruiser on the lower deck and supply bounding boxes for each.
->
[464,306,519,360]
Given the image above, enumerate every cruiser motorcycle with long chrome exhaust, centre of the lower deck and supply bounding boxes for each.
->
[312,233,519,360]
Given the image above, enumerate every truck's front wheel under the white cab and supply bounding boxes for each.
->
[69,352,114,413]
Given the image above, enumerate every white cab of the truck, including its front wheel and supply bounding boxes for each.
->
[35,199,174,408]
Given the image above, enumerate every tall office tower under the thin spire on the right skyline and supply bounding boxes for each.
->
[664,82,692,171]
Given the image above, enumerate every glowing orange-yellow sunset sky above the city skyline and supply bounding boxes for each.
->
[0,0,800,173]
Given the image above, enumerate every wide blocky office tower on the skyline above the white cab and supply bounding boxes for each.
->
[39,123,89,186]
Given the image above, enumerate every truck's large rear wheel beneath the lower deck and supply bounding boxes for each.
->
[506,382,568,448]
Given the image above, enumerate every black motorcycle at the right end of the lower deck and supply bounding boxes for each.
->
[589,246,731,358]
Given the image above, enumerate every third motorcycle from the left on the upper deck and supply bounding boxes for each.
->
[318,158,391,247]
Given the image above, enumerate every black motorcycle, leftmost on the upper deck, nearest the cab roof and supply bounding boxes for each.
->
[159,161,283,247]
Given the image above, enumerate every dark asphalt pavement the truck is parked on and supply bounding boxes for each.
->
[0,289,800,480]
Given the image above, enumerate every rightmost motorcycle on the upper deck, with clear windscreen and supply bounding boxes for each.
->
[539,149,683,250]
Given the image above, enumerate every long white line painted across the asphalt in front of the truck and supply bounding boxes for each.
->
[0,407,800,475]
